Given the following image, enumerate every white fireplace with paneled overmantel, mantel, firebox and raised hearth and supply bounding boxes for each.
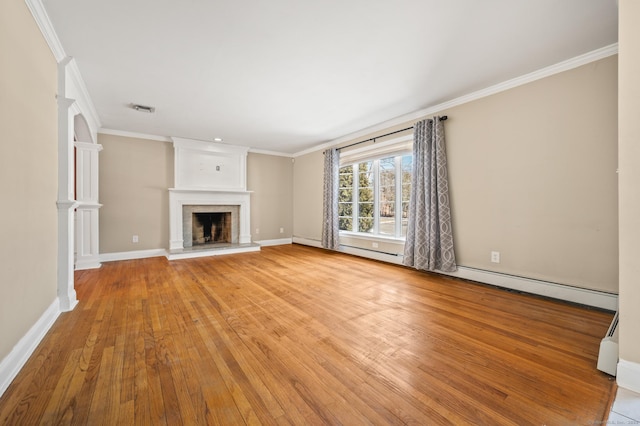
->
[167,138,260,260]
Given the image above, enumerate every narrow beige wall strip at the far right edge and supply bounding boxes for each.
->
[619,0,640,366]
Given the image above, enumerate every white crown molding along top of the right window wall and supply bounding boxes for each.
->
[292,43,618,158]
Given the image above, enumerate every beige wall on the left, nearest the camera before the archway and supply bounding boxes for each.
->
[0,0,58,361]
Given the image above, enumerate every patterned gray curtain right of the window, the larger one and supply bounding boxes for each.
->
[404,117,456,272]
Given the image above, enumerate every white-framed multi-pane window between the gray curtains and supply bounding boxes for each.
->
[338,153,412,238]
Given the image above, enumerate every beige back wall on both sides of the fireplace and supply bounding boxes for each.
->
[98,134,293,253]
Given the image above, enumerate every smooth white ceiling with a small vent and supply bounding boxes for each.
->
[43,0,618,153]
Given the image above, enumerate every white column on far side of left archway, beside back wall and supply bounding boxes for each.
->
[74,142,102,270]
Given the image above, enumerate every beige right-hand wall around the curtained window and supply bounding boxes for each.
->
[294,56,618,292]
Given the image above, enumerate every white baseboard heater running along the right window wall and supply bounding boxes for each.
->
[293,237,618,311]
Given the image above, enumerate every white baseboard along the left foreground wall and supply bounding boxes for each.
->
[0,298,61,397]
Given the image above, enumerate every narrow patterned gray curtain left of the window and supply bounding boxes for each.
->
[322,148,340,250]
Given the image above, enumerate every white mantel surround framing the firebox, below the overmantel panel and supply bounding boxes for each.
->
[169,188,251,250]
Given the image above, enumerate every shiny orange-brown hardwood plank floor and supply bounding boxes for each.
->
[0,245,614,425]
